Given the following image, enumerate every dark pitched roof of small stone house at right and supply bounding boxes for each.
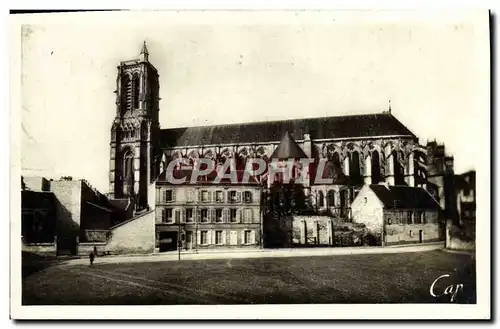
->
[370,185,440,210]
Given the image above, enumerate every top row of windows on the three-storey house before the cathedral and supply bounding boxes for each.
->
[156,190,253,203]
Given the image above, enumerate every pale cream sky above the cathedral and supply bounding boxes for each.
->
[20,11,490,192]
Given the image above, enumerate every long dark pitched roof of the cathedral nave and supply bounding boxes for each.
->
[160,112,416,147]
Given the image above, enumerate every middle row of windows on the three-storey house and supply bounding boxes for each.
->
[161,208,254,223]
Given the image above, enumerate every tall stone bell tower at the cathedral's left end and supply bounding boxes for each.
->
[109,42,160,210]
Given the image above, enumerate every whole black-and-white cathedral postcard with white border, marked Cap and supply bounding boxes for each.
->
[10,10,492,320]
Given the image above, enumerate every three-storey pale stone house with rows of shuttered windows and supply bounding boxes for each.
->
[156,177,262,251]
